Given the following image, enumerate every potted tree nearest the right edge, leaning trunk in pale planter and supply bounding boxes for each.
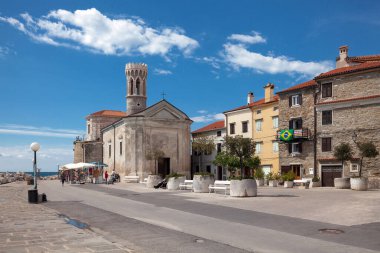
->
[350,142,379,191]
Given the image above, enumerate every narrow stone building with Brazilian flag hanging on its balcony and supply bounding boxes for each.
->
[278,80,317,178]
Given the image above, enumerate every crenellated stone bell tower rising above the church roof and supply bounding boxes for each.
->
[125,63,148,115]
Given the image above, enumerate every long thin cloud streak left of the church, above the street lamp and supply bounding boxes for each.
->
[0,124,84,139]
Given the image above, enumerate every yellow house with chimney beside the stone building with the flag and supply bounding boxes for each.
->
[250,83,280,174]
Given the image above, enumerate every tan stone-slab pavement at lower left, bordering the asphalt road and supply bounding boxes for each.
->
[0,182,136,253]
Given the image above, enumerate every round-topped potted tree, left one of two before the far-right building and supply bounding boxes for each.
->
[334,142,353,189]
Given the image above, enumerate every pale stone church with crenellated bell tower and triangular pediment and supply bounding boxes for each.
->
[74,63,192,180]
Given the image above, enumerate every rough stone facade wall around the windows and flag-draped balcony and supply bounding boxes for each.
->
[279,87,314,176]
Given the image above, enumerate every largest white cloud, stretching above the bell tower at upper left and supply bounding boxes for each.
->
[0,8,199,58]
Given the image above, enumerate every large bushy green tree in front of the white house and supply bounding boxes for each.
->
[224,135,260,178]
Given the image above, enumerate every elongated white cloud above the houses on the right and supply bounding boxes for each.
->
[223,43,333,76]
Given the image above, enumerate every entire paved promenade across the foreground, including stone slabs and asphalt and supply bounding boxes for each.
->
[0,181,380,253]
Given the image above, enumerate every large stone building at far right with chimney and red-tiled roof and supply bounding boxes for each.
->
[315,46,380,188]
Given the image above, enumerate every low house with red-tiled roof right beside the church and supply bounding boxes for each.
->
[191,120,228,180]
